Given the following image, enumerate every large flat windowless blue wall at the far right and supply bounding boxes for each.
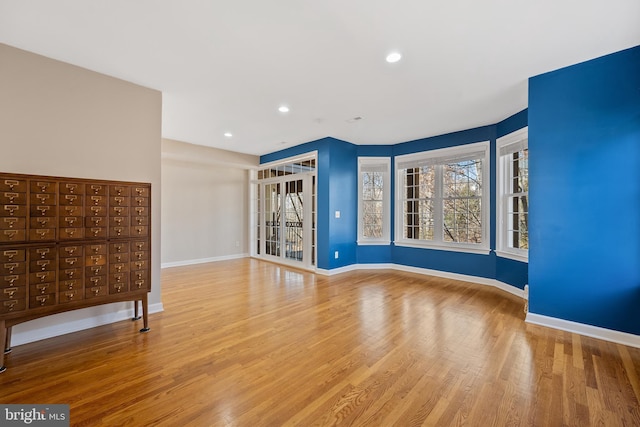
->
[529,46,640,334]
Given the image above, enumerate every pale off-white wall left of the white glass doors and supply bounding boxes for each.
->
[162,139,259,267]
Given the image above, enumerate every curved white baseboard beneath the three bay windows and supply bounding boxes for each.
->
[317,264,528,299]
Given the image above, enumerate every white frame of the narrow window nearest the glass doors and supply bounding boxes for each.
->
[358,157,391,245]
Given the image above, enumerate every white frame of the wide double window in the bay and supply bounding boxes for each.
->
[394,141,491,254]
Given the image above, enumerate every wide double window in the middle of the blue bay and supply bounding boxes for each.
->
[395,142,489,253]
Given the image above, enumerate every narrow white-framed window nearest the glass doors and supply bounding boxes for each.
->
[358,157,391,245]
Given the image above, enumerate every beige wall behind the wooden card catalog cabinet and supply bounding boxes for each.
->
[0,44,162,345]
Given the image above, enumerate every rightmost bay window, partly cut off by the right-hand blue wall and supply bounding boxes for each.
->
[496,128,529,261]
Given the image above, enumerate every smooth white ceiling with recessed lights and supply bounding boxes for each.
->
[0,0,640,154]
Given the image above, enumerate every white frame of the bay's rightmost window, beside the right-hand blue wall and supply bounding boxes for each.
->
[495,126,529,262]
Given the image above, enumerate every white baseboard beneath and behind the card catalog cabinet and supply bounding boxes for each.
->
[11,303,164,347]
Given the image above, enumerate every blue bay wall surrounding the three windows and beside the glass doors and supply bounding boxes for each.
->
[260,119,528,289]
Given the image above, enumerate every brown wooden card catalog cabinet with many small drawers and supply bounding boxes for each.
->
[0,173,151,372]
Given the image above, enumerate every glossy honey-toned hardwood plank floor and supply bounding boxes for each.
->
[0,259,640,426]
